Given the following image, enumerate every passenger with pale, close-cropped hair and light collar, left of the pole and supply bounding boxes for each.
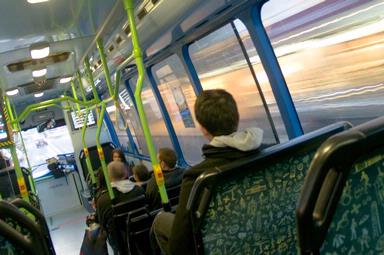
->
[96,161,144,251]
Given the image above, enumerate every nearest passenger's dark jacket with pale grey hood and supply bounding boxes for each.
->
[166,128,263,255]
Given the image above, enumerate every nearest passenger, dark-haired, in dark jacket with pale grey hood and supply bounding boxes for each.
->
[151,89,263,254]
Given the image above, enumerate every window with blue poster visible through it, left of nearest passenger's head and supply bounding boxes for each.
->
[153,55,207,165]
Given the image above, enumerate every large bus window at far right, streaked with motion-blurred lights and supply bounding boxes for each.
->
[261,0,384,132]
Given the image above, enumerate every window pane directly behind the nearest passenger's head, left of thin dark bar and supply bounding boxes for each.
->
[189,20,276,143]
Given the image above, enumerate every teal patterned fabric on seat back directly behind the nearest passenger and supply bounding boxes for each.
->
[201,150,315,255]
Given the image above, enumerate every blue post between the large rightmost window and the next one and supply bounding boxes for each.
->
[239,2,303,139]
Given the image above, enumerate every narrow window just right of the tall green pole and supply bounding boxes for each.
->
[129,75,173,151]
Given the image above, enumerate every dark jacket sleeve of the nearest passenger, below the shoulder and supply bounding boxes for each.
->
[168,172,195,254]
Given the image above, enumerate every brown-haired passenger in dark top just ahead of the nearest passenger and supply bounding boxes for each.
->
[145,148,184,209]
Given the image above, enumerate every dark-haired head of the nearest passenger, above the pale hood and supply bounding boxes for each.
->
[195,89,239,140]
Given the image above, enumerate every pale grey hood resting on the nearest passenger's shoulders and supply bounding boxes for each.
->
[209,127,263,151]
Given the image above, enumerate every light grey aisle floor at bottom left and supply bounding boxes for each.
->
[47,207,113,255]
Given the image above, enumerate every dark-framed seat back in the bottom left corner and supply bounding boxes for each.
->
[0,198,56,255]
